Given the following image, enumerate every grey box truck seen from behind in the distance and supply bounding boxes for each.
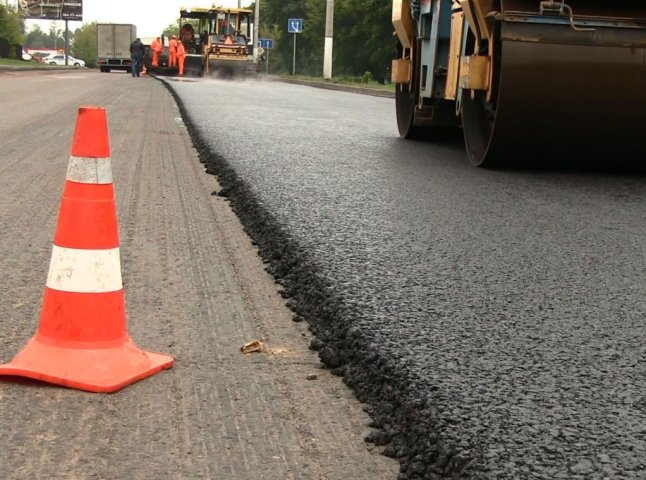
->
[96,23,137,72]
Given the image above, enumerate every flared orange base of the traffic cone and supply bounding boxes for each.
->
[0,336,175,393]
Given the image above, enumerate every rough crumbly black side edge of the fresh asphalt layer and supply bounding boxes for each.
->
[156,78,478,480]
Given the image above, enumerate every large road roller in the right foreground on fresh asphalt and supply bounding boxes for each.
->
[391,0,646,167]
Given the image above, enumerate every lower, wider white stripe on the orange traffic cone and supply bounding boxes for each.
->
[47,245,123,293]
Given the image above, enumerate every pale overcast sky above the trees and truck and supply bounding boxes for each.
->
[21,0,249,38]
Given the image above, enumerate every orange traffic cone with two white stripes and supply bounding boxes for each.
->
[0,107,174,392]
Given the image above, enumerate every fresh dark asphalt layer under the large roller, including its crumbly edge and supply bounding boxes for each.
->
[168,80,646,480]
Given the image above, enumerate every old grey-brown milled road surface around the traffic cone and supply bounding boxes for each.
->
[0,71,397,480]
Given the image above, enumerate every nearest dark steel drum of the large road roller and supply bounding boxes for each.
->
[462,22,646,166]
